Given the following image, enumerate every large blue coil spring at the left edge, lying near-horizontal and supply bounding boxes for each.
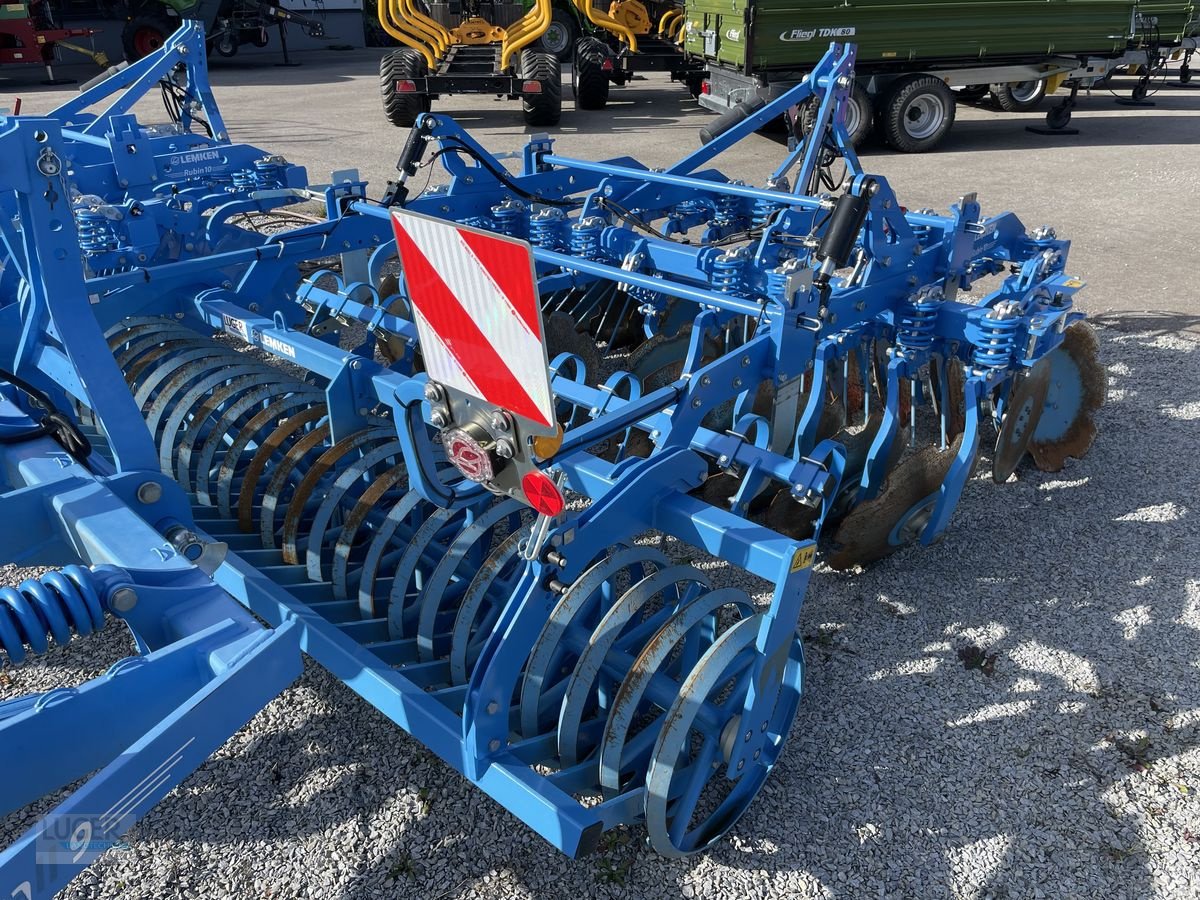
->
[0,565,104,664]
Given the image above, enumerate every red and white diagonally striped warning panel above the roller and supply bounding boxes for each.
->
[391,210,557,428]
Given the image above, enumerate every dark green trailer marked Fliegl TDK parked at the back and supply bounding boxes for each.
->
[684,0,1198,152]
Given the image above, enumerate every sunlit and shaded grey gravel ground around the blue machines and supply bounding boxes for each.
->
[0,316,1200,900]
